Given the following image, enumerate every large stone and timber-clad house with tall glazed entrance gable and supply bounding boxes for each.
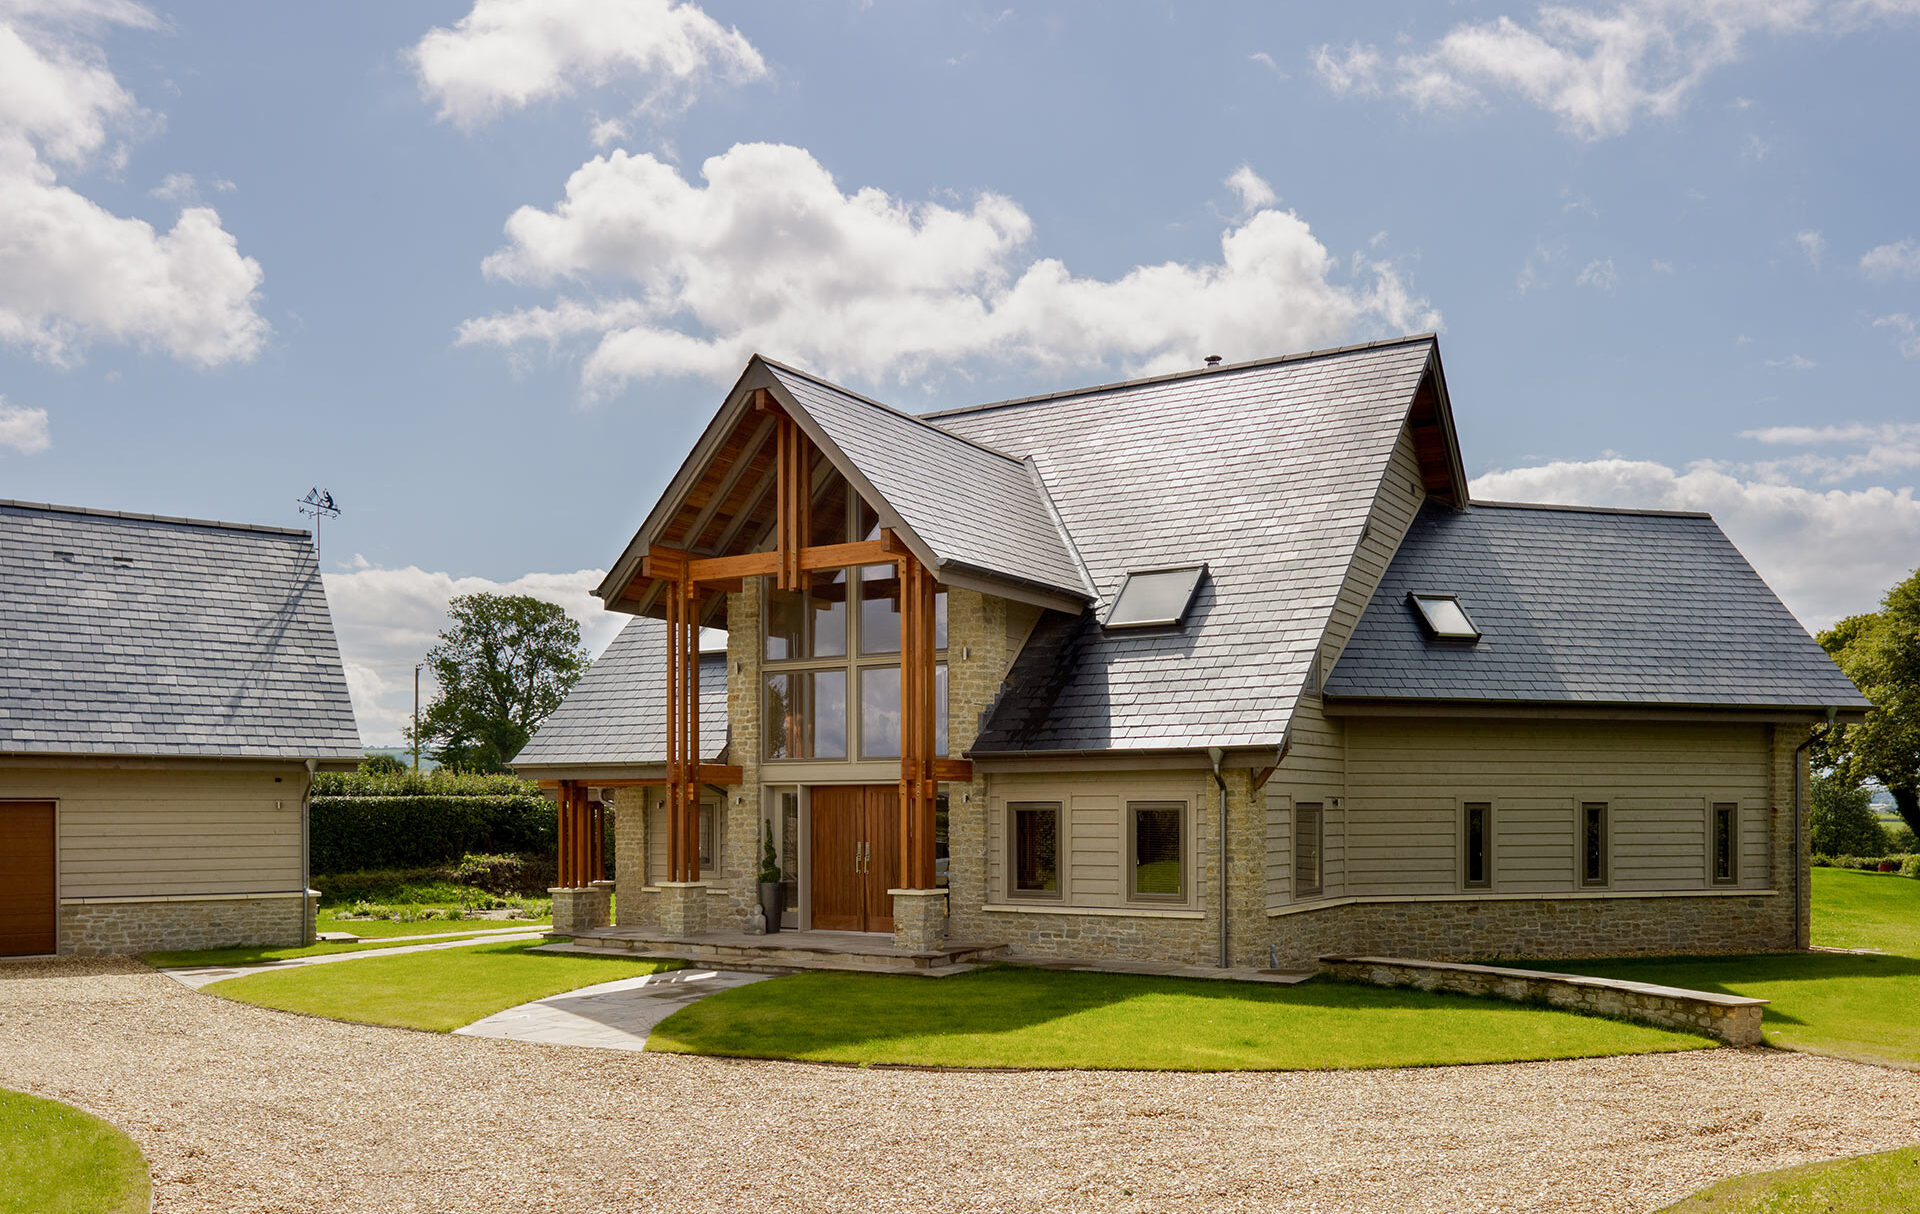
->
[516,334,1866,966]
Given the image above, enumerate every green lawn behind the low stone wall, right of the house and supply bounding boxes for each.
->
[1530,868,1920,1066]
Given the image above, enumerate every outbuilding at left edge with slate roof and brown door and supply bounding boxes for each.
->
[0,501,361,957]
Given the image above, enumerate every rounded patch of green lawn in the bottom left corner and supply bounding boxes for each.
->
[0,1091,152,1214]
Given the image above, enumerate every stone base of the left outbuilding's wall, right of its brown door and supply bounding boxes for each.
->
[60,889,321,957]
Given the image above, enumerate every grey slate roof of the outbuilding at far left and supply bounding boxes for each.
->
[0,501,361,759]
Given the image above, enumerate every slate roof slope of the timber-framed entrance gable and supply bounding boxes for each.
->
[766,361,1092,597]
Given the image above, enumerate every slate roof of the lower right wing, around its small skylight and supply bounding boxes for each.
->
[1327,501,1866,709]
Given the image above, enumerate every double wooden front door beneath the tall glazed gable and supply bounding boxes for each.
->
[810,784,900,932]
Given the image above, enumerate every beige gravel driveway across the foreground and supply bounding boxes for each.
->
[0,960,1920,1214]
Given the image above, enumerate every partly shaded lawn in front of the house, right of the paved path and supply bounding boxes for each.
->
[647,966,1713,1070]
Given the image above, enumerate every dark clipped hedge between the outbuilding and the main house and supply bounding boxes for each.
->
[309,791,559,872]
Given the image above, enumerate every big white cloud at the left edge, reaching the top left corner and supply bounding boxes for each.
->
[0,0,267,367]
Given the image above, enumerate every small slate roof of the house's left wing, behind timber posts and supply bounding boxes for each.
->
[513,617,728,768]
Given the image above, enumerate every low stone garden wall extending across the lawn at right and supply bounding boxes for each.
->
[1321,957,1766,1045]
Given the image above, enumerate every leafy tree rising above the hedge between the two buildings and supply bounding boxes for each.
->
[409,594,588,772]
